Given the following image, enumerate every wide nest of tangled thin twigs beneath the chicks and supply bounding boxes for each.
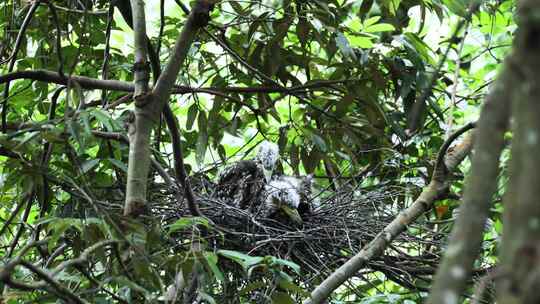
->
[152,179,444,289]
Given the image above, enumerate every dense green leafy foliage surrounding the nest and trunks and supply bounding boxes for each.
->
[0,0,516,303]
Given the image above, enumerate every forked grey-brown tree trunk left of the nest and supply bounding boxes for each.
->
[124,0,213,216]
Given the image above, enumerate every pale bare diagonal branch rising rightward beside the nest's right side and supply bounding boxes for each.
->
[304,123,474,304]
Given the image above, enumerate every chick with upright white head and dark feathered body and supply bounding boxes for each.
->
[216,141,279,210]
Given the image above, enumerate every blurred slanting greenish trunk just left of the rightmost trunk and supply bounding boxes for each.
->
[427,69,512,304]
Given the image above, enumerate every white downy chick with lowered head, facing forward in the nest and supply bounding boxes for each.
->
[262,177,303,224]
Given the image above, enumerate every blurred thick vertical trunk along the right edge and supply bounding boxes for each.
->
[496,0,540,304]
